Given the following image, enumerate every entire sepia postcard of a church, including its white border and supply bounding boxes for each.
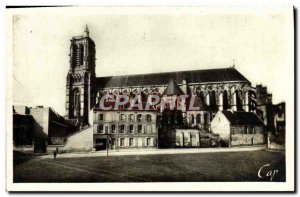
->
[6,6,295,192]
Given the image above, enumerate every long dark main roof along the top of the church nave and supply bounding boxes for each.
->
[96,67,250,88]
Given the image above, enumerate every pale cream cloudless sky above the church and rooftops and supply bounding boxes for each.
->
[8,7,294,115]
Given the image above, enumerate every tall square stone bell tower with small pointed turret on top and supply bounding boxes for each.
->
[66,26,96,125]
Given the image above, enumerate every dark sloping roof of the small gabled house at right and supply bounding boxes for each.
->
[222,111,264,126]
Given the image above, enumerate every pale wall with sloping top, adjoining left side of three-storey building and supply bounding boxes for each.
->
[63,127,93,152]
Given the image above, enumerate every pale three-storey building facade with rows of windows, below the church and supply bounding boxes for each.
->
[93,110,157,150]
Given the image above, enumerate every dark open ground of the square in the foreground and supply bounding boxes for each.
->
[14,150,285,182]
